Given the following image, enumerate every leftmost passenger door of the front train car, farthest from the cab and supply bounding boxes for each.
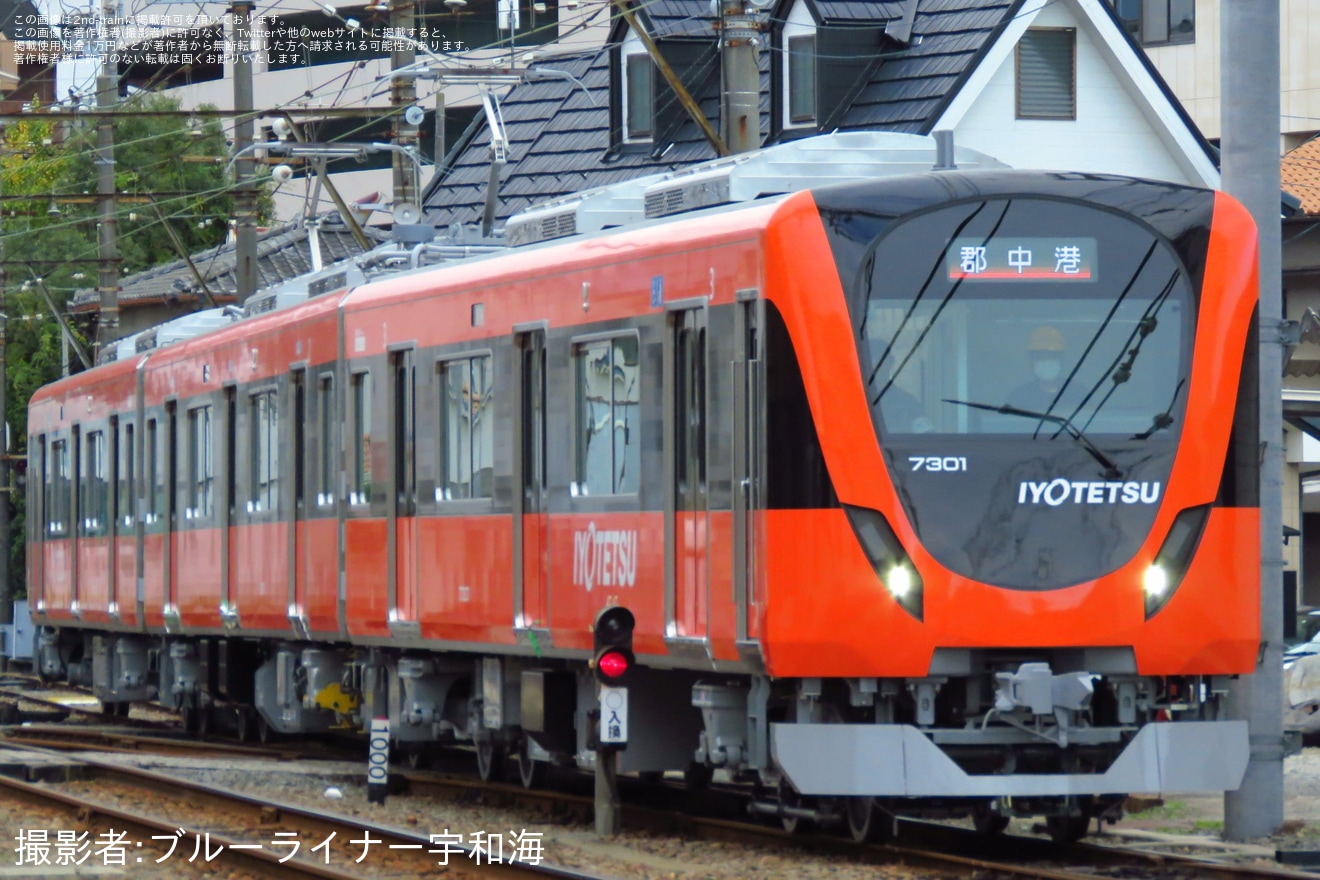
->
[387,348,420,635]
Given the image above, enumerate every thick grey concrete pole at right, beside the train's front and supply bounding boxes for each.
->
[1220,0,1283,840]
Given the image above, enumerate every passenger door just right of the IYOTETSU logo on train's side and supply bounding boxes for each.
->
[665,306,709,640]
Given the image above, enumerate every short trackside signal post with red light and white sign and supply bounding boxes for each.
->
[591,606,636,838]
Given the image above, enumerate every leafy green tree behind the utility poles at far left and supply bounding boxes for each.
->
[0,92,272,596]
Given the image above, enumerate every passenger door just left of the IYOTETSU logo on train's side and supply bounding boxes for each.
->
[513,325,549,629]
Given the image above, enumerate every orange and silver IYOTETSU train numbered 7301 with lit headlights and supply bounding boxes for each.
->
[28,172,1259,836]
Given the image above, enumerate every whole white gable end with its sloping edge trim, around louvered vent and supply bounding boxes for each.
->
[936,0,1217,186]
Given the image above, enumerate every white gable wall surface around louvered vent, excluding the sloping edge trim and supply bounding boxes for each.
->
[954,3,1200,183]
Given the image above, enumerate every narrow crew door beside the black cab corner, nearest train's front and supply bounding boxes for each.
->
[733,290,764,648]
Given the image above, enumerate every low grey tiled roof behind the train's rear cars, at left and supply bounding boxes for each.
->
[69,214,384,336]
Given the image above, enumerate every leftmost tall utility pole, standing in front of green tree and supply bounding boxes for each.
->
[94,0,119,353]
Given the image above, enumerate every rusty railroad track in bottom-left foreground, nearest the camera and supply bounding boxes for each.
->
[0,743,612,880]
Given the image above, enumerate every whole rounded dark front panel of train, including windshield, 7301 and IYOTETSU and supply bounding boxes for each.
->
[855,198,1196,590]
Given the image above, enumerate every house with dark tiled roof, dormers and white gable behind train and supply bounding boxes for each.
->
[425,0,1218,227]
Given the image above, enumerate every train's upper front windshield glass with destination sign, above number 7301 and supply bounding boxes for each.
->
[861,199,1193,439]
